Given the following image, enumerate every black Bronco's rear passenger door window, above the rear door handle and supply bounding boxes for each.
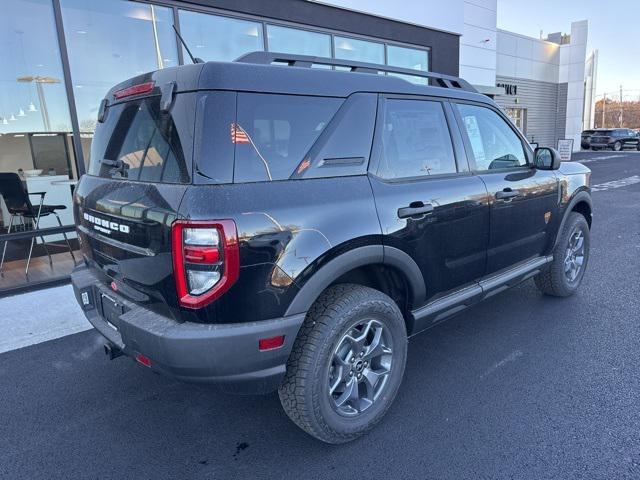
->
[378,100,456,179]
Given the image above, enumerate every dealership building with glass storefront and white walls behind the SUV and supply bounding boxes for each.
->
[0,0,597,295]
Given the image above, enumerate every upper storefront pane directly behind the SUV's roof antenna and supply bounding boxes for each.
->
[180,10,264,62]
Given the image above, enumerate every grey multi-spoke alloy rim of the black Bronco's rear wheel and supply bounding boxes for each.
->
[328,319,393,417]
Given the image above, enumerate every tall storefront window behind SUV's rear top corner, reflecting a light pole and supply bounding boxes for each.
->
[60,0,178,171]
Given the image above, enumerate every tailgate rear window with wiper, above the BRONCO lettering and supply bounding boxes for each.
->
[89,94,193,183]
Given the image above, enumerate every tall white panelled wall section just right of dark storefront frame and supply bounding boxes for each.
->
[460,0,498,87]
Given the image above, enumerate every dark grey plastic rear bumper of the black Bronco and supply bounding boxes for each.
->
[71,266,304,393]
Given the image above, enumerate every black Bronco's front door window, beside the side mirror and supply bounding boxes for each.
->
[457,104,527,170]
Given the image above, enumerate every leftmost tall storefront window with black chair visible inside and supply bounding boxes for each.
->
[0,0,78,291]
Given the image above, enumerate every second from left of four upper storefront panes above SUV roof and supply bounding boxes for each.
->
[267,25,331,58]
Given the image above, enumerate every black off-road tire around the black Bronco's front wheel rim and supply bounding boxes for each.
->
[534,212,590,297]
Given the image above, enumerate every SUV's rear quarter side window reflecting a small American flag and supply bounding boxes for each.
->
[232,93,344,182]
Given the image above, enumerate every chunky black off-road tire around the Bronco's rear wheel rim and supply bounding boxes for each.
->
[278,284,407,444]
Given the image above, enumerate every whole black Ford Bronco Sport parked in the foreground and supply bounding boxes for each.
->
[72,53,591,443]
